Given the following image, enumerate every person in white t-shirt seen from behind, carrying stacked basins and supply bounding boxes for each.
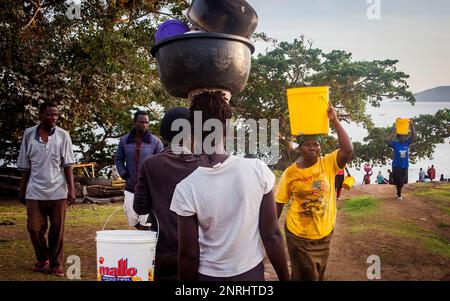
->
[170,91,289,281]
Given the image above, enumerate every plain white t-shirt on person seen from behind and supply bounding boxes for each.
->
[170,156,275,277]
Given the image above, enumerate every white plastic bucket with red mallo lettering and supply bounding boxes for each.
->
[95,230,158,281]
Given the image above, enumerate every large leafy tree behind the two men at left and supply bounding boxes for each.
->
[0,0,188,168]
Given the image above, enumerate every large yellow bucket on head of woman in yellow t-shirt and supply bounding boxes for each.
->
[287,87,330,136]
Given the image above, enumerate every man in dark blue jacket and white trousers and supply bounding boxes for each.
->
[114,111,163,230]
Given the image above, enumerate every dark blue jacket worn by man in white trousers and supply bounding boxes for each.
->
[114,129,164,192]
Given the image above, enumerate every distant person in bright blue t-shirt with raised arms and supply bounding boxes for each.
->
[387,118,416,201]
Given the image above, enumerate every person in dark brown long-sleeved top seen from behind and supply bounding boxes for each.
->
[133,107,222,281]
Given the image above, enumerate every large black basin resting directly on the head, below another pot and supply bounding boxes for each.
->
[151,33,255,98]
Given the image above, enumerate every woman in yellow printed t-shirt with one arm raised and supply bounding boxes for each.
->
[276,104,353,281]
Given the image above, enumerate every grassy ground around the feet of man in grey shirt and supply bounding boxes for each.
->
[0,202,132,280]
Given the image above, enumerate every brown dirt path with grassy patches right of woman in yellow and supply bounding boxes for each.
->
[267,185,450,281]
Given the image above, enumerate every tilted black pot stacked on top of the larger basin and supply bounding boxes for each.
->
[186,0,258,39]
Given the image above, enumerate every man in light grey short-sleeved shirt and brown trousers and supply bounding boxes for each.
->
[17,102,75,277]
